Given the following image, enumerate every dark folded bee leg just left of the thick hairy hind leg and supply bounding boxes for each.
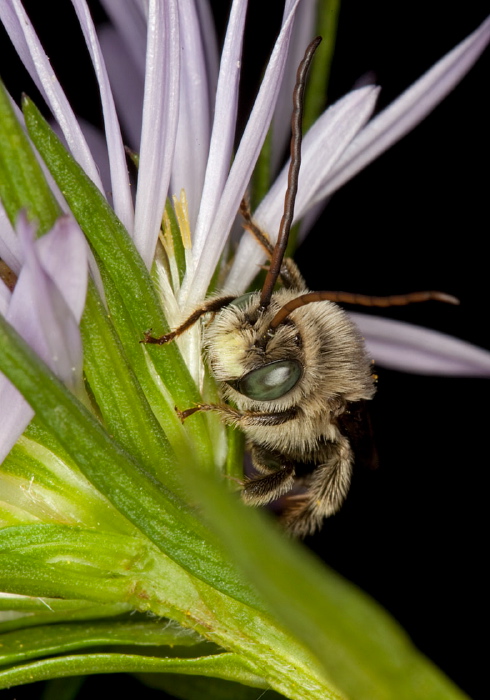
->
[242,446,296,506]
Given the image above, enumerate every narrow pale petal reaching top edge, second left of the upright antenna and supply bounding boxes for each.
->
[187,0,247,270]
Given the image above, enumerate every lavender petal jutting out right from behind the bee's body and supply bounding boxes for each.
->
[350,313,490,377]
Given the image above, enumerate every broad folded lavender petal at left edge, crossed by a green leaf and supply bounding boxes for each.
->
[0,214,87,462]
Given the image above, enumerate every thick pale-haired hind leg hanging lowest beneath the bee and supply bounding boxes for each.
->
[281,436,353,537]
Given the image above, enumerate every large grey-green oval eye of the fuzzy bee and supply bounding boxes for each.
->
[232,360,303,401]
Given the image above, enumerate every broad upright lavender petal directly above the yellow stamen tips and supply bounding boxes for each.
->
[170,0,211,231]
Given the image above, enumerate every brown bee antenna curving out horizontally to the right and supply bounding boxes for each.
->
[269,292,459,330]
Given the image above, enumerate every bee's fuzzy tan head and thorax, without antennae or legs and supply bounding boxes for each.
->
[204,290,373,411]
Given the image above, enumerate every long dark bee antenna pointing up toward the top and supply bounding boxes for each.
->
[260,36,322,308]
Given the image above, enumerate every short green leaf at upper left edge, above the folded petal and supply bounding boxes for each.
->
[0,81,61,233]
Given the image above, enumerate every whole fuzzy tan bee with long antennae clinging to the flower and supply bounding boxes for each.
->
[143,38,458,537]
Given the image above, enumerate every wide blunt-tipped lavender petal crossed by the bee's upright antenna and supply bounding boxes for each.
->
[225,86,378,292]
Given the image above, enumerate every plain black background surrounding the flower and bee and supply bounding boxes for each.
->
[0,0,490,700]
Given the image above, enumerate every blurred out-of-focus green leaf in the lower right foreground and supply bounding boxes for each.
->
[180,470,466,700]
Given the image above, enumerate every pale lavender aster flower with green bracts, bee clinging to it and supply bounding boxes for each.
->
[0,0,489,698]
